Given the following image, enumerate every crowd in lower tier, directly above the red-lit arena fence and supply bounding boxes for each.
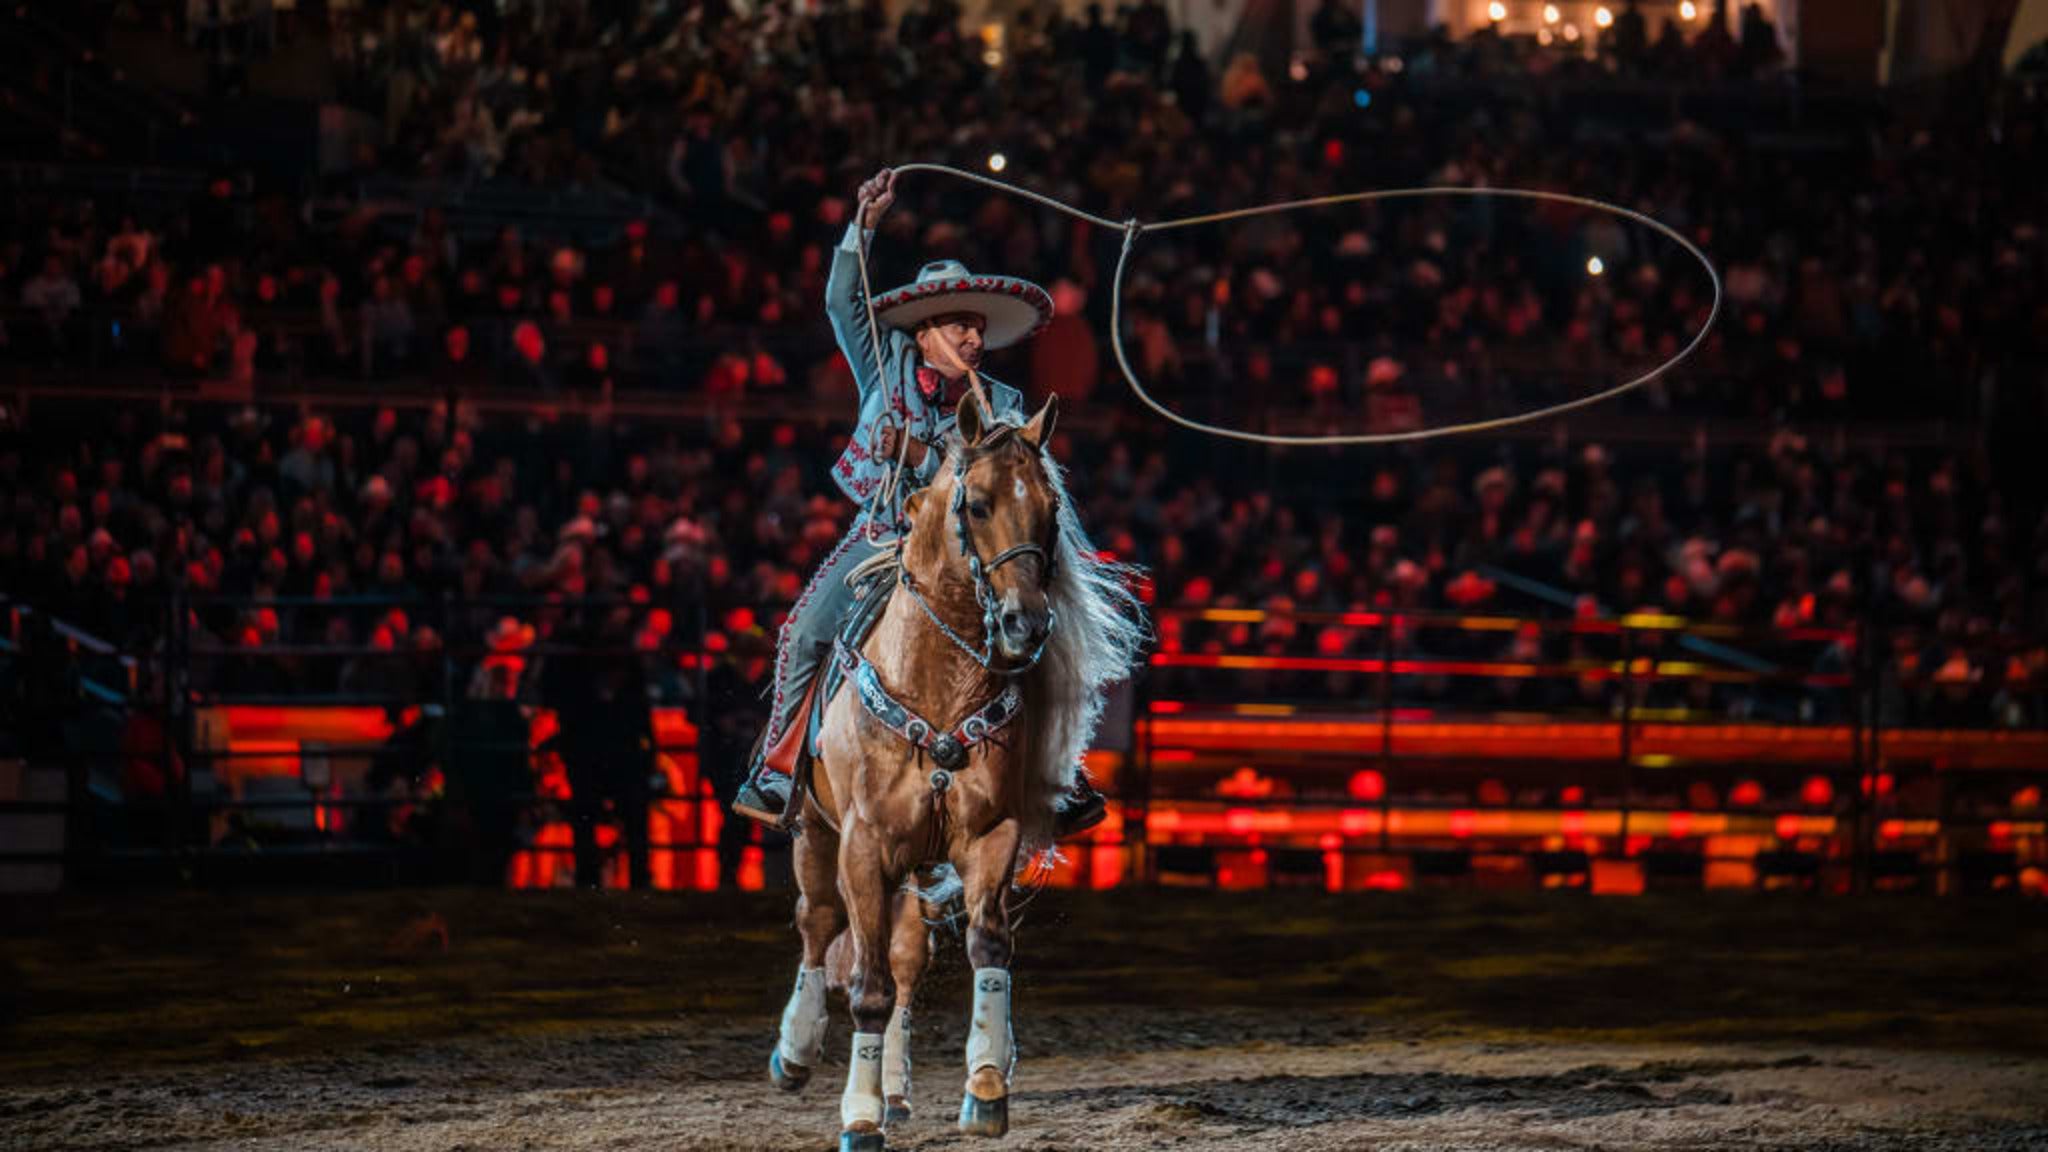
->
[0,389,2048,715]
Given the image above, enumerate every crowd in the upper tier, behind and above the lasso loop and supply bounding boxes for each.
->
[0,2,2048,426]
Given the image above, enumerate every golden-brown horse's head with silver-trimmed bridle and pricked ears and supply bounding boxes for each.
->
[905,387,1059,664]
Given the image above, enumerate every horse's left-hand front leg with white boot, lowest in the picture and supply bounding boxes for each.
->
[840,818,903,1152]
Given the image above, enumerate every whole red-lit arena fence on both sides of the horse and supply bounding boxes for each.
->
[0,596,2048,894]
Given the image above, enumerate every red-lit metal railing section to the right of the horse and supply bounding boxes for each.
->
[1120,609,2048,890]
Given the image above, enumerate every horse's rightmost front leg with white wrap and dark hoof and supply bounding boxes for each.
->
[954,818,1022,1136]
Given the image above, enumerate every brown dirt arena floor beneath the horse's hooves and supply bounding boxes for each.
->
[0,892,2048,1152]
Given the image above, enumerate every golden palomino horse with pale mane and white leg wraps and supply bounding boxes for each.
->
[770,389,1143,1152]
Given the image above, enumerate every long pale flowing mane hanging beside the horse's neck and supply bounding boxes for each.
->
[948,426,1151,853]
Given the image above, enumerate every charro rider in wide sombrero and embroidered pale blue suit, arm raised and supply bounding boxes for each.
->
[733,168,1104,836]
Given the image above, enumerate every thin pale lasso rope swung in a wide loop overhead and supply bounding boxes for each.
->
[854,162,1722,448]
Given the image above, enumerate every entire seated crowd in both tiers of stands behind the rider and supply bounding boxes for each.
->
[0,0,2048,719]
